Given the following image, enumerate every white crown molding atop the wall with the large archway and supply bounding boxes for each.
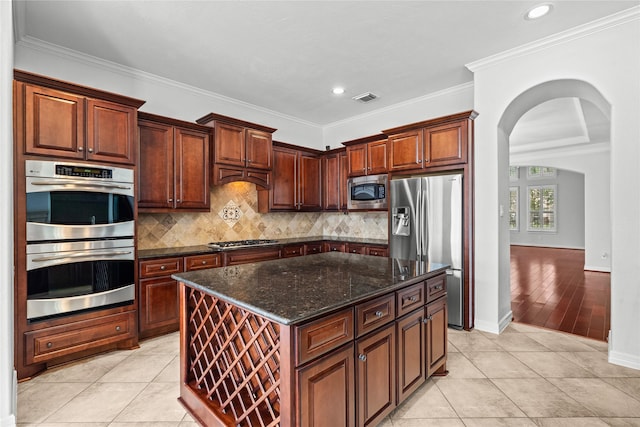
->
[465,6,640,73]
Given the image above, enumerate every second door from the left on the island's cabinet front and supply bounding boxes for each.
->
[356,323,396,426]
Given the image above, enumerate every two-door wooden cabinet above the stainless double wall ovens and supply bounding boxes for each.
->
[14,70,144,165]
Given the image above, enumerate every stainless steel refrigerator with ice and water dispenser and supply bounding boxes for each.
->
[389,174,464,329]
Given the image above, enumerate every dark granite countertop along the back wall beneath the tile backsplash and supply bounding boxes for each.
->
[138,236,387,259]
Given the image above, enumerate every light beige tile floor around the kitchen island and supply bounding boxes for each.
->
[18,323,640,427]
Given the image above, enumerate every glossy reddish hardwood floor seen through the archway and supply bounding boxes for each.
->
[511,245,611,341]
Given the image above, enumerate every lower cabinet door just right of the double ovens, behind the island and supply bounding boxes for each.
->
[139,277,180,338]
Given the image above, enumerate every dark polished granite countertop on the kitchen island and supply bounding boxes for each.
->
[172,252,448,325]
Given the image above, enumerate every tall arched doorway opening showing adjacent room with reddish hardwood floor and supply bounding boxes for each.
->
[500,80,611,341]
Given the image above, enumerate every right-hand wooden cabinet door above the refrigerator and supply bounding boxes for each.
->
[424,120,468,166]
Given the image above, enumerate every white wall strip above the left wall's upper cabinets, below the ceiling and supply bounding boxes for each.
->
[15,41,324,149]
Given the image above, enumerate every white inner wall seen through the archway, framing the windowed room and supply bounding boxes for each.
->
[510,150,611,272]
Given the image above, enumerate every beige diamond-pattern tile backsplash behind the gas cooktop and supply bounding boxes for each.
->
[137,182,388,249]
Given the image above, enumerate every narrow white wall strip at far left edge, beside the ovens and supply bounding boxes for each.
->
[0,1,16,426]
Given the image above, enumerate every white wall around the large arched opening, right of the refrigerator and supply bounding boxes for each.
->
[470,7,640,369]
